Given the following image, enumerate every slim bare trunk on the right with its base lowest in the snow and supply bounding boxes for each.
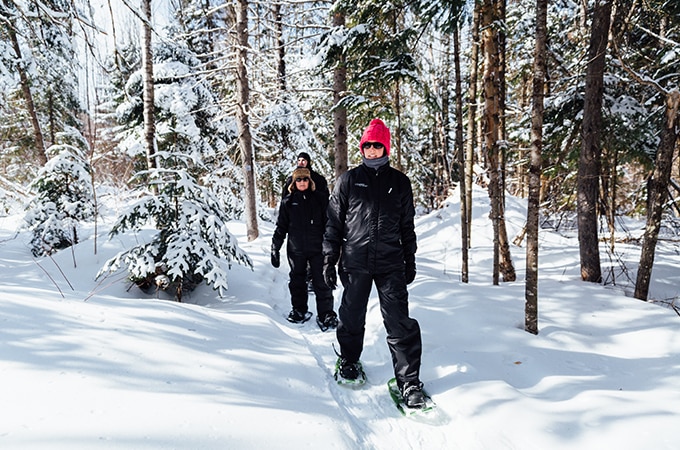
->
[524,0,548,334]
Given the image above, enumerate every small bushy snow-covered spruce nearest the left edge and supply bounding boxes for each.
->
[24,127,96,256]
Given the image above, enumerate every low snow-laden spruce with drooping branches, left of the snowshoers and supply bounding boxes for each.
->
[99,160,252,301]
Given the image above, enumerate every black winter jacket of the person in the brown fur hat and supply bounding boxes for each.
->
[272,190,328,255]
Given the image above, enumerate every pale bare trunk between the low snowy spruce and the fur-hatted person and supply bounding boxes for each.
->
[236,0,259,241]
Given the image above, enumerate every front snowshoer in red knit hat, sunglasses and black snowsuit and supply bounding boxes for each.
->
[323,119,425,408]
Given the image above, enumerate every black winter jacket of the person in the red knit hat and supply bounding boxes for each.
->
[323,163,417,274]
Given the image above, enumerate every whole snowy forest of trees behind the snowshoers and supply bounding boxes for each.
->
[0,0,680,316]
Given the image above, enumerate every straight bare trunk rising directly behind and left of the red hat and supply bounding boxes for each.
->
[333,12,349,180]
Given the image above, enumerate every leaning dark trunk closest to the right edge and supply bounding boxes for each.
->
[634,90,680,300]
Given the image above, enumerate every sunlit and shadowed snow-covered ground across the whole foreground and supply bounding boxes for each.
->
[0,191,680,450]
